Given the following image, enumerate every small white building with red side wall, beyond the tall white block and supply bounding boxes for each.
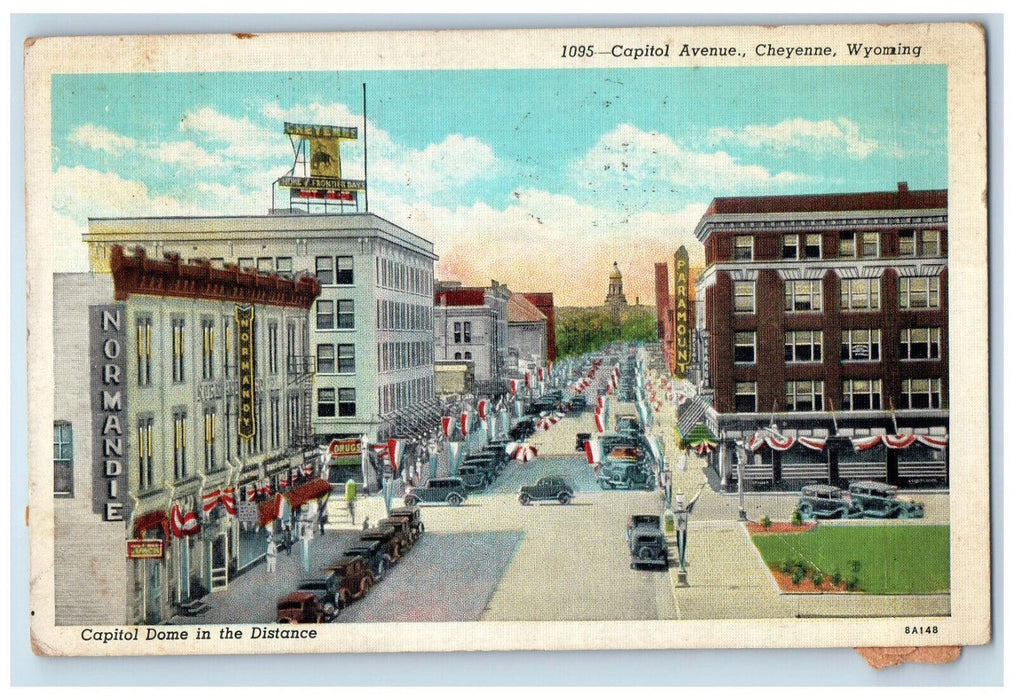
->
[433,280,510,397]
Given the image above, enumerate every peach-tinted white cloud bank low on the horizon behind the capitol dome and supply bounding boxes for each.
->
[377,190,707,305]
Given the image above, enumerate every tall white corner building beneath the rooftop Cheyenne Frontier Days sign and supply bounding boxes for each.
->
[84,210,437,443]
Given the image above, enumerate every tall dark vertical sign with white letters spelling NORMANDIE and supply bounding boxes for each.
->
[88,303,131,521]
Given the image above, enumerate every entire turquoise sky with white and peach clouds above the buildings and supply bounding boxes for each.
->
[52,66,947,304]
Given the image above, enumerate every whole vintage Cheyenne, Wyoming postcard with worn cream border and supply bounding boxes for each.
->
[24,23,991,655]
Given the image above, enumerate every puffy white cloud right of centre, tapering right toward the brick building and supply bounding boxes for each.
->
[571,124,805,197]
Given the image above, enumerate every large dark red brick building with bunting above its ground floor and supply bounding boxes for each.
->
[680,183,949,486]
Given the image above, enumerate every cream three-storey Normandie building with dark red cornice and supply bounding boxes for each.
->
[54,247,320,625]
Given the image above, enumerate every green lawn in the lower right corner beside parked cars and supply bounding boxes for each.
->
[753,522,950,593]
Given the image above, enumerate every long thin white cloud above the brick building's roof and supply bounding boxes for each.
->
[708,118,891,159]
